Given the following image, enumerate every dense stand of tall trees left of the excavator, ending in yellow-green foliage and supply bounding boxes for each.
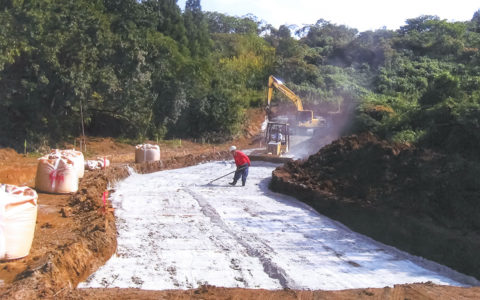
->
[0,0,274,148]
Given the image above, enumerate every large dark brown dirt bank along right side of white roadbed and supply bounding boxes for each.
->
[271,133,480,278]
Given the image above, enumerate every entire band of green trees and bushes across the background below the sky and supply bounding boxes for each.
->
[0,0,480,156]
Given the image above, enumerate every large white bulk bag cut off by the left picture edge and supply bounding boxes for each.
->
[0,184,38,260]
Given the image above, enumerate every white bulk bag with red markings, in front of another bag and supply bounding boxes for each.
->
[35,156,78,194]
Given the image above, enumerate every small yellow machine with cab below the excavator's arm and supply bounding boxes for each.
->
[265,122,290,156]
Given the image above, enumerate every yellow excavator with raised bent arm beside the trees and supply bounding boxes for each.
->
[266,75,326,134]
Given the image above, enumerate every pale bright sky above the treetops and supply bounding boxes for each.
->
[177,0,480,32]
